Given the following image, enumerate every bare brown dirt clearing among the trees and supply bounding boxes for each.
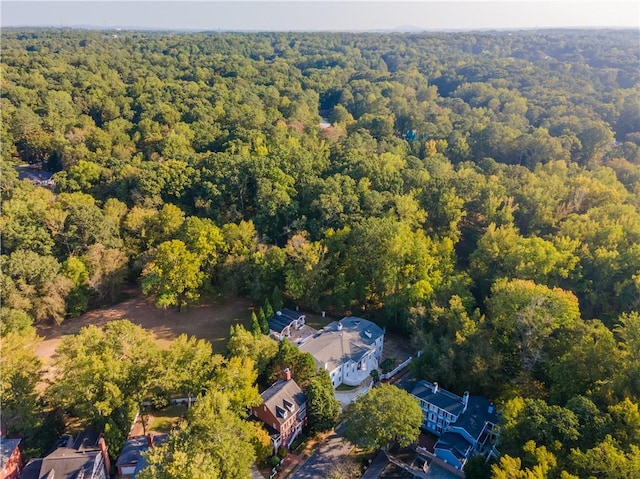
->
[36,296,252,362]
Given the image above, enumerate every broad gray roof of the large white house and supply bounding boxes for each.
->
[300,316,384,371]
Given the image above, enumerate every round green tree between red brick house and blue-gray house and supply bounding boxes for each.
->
[344,384,422,449]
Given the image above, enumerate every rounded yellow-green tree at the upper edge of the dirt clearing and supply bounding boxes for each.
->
[142,240,203,311]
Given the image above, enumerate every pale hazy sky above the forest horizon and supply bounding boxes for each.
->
[0,0,640,31]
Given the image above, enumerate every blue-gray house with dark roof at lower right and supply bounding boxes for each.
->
[411,381,499,470]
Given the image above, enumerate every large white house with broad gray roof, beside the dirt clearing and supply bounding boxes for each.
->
[299,317,384,388]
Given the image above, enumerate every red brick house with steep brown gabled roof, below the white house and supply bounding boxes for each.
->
[251,369,307,452]
